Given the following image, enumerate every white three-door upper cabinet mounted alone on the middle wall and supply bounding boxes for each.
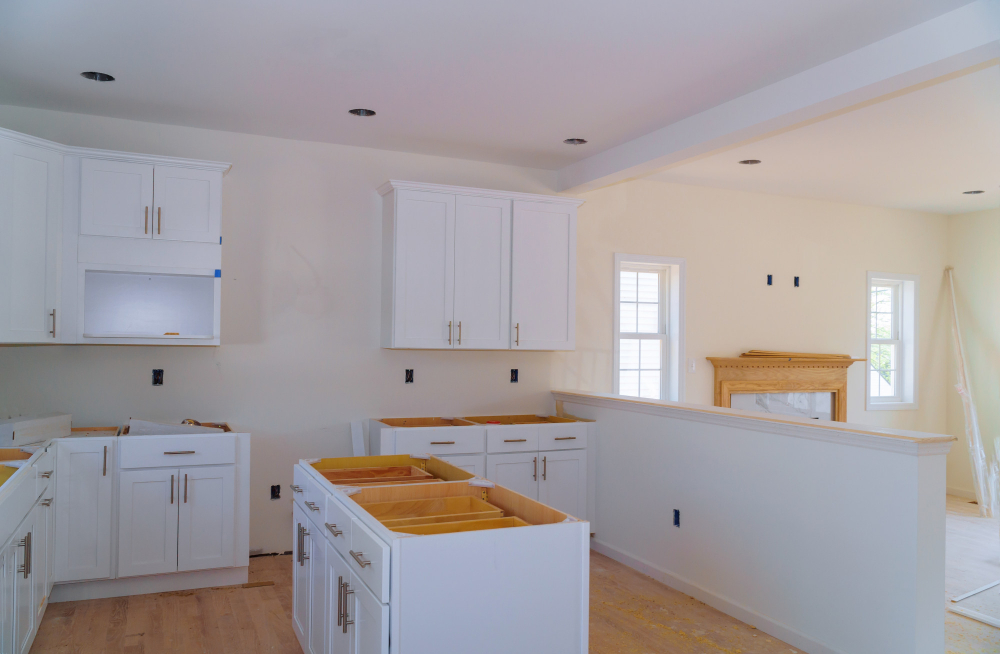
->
[379,181,582,350]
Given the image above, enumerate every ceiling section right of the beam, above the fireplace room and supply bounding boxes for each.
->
[650,65,1000,214]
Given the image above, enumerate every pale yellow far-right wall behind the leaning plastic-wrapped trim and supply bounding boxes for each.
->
[945,209,1000,497]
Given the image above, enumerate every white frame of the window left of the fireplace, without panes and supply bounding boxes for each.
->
[611,253,687,402]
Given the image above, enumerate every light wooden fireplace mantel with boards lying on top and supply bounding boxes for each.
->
[706,350,865,422]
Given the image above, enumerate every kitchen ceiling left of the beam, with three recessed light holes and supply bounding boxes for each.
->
[0,0,976,169]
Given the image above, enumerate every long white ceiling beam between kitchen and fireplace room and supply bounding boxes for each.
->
[558,0,1000,193]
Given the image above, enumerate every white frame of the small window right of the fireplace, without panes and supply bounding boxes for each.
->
[865,271,920,411]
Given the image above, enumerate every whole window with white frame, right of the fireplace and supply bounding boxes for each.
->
[867,273,917,410]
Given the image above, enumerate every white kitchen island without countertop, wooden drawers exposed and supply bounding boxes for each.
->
[292,455,589,654]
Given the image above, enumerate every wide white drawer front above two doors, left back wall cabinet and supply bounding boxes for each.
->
[120,434,236,468]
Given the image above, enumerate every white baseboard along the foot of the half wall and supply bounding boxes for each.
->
[590,538,846,654]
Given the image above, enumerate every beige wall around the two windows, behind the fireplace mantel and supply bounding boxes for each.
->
[552,181,948,432]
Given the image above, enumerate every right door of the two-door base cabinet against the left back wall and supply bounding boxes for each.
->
[177,466,236,571]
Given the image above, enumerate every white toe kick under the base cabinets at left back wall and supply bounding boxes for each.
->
[49,567,250,604]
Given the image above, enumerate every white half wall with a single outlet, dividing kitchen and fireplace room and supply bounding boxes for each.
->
[556,393,950,654]
